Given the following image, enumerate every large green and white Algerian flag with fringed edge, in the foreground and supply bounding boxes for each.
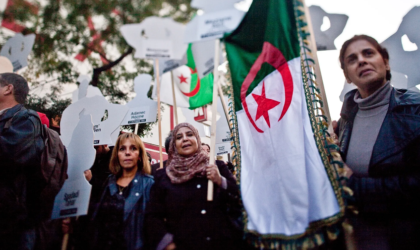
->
[225,0,343,249]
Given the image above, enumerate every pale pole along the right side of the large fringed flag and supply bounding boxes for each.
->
[302,0,331,124]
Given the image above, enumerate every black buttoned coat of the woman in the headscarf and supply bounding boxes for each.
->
[145,161,242,250]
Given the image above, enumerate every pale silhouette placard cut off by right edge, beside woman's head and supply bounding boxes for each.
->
[382,6,420,89]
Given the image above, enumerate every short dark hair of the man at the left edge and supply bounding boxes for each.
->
[0,73,29,104]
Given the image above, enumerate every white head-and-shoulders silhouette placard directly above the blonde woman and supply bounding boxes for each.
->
[121,74,157,125]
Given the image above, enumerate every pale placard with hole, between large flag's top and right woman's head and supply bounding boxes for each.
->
[309,5,349,50]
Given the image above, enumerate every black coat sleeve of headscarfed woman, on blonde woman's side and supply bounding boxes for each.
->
[144,171,168,249]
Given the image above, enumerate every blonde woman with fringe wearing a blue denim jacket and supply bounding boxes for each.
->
[88,133,154,250]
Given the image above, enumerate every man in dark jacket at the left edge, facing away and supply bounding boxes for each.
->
[0,73,44,249]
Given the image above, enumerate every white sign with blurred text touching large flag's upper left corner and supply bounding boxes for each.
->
[184,9,245,43]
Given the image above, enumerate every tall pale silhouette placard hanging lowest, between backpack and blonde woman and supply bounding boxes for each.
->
[51,111,96,219]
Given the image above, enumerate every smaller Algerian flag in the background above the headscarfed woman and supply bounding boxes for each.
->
[154,44,213,109]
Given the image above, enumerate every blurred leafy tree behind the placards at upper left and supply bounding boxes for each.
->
[0,0,193,137]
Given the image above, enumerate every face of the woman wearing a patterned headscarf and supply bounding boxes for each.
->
[175,127,198,156]
